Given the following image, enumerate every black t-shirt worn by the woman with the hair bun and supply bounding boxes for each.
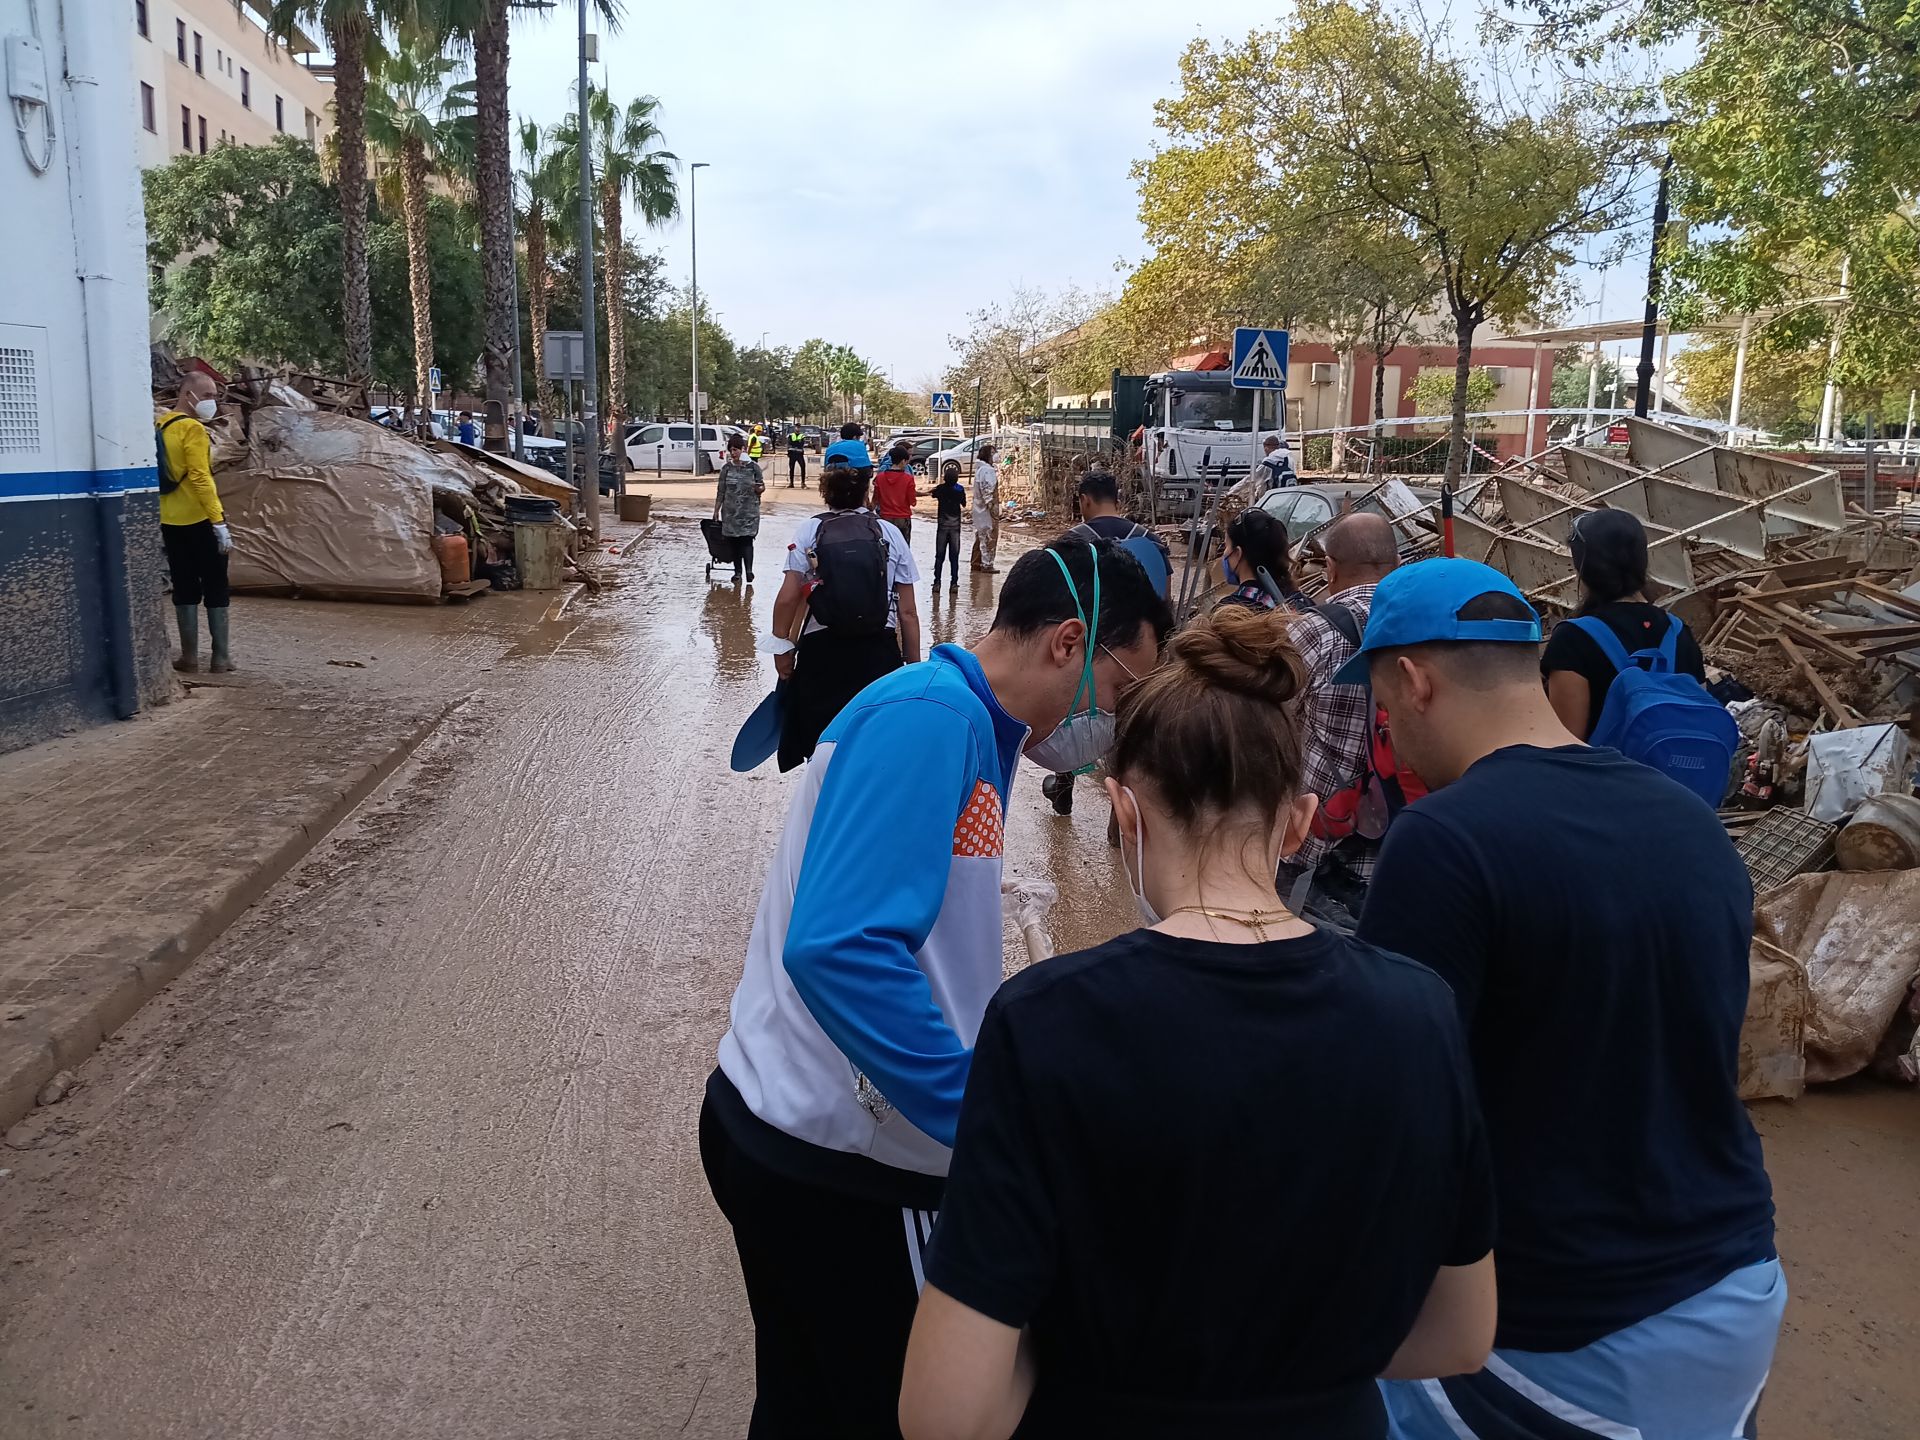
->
[925,929,1494,1440]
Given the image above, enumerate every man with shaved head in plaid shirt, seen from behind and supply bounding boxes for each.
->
[1279,515,1400,920]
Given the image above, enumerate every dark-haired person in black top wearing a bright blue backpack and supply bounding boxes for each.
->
[1540,509,1707,739]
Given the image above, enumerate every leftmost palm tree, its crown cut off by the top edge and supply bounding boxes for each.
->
[267,0,419,384]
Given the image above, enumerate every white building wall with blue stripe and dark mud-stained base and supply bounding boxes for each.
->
[0,0,175,751]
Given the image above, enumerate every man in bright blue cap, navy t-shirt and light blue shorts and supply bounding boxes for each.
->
[1336,561,1786,1440]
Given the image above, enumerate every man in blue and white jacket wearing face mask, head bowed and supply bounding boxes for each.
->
[701,540,1169,1440]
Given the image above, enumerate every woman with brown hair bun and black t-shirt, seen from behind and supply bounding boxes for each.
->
[900,607,1494,1440]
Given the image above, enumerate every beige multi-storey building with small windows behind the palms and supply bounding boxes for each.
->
[131,0,334,169]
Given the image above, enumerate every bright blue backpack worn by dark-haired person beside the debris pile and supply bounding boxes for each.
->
[1567,614,1740,806]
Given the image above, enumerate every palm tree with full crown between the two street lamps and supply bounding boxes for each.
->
[553,84,680,463]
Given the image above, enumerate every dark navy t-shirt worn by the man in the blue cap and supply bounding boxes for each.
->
[1359,745,1774,1350]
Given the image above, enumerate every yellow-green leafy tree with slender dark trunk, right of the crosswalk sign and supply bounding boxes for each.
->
[1150,0,1638,478]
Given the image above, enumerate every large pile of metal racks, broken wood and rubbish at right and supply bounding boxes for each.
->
[1455,420,1920,1098]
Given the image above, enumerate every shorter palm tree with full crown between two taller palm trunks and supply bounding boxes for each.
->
[367,35,472,420]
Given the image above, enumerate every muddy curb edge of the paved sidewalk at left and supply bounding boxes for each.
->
[0,701,465,1131]
